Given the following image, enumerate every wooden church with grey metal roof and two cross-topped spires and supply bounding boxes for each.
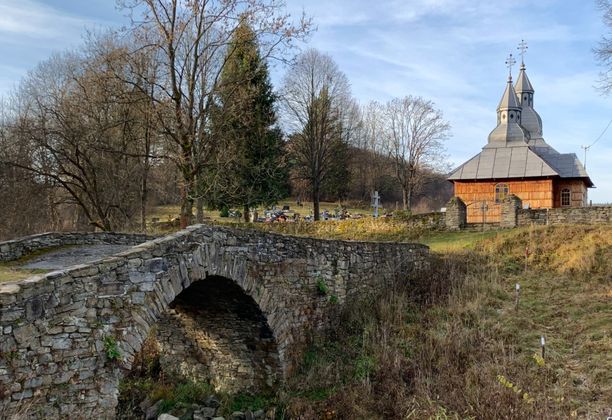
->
[448,43,593,223]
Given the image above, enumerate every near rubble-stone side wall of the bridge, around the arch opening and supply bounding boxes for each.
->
[0,226,428,418]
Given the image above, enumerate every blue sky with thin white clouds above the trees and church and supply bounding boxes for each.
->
[0,0,612,203]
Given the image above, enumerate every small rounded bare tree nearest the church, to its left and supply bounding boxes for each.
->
[382,96,450,210]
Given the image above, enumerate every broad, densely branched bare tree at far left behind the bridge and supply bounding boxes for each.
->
[4,36,157,230]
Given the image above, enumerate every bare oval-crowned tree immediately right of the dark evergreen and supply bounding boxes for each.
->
[283,49,355,220]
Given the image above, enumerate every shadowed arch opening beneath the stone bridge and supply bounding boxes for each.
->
[134,275,282,392]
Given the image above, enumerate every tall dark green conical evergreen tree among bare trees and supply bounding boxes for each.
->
[212,19,288,220]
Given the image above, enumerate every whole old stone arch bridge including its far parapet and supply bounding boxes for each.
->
[0,225,428,418]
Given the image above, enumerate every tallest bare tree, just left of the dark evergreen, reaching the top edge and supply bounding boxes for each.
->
[119,0,311,227]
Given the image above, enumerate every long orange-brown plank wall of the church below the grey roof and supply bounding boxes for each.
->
[454,179,554,223]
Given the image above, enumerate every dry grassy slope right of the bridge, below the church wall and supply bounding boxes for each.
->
[285,226,612,419]
